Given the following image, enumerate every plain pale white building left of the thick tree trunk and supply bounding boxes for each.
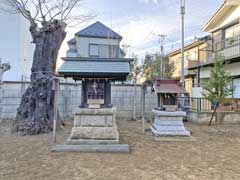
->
[0,0,34,81]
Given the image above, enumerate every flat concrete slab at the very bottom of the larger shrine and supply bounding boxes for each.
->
[51,144,129,153]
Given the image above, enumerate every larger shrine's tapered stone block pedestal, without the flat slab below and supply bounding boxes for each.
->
[67,108,119,144]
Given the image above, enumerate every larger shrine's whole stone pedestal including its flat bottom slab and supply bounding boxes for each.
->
[53,108,129,152]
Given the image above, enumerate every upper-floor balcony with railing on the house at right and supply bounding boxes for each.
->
[199,36,240,65]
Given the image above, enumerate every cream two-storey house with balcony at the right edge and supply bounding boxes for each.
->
[188,0,240,98]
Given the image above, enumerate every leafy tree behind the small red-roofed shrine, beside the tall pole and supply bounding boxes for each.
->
[142,54,174,84]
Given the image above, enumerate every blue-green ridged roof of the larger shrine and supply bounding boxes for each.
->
[58,57,132,80]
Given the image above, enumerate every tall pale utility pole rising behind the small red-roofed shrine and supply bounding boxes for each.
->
[181,0,185,87]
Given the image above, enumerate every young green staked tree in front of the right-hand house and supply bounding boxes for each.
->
[203,59,234,125]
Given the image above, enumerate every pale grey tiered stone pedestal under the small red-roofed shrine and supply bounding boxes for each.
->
[151,109,190,136]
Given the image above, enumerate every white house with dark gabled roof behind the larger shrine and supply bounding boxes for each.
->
[66,21,125,58]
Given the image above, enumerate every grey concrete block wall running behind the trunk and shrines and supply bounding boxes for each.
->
[0,82,157,119]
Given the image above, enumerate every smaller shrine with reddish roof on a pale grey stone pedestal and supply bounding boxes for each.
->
[151,79,190,136]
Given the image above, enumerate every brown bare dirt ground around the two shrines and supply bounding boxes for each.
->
[0,121,240,180]
